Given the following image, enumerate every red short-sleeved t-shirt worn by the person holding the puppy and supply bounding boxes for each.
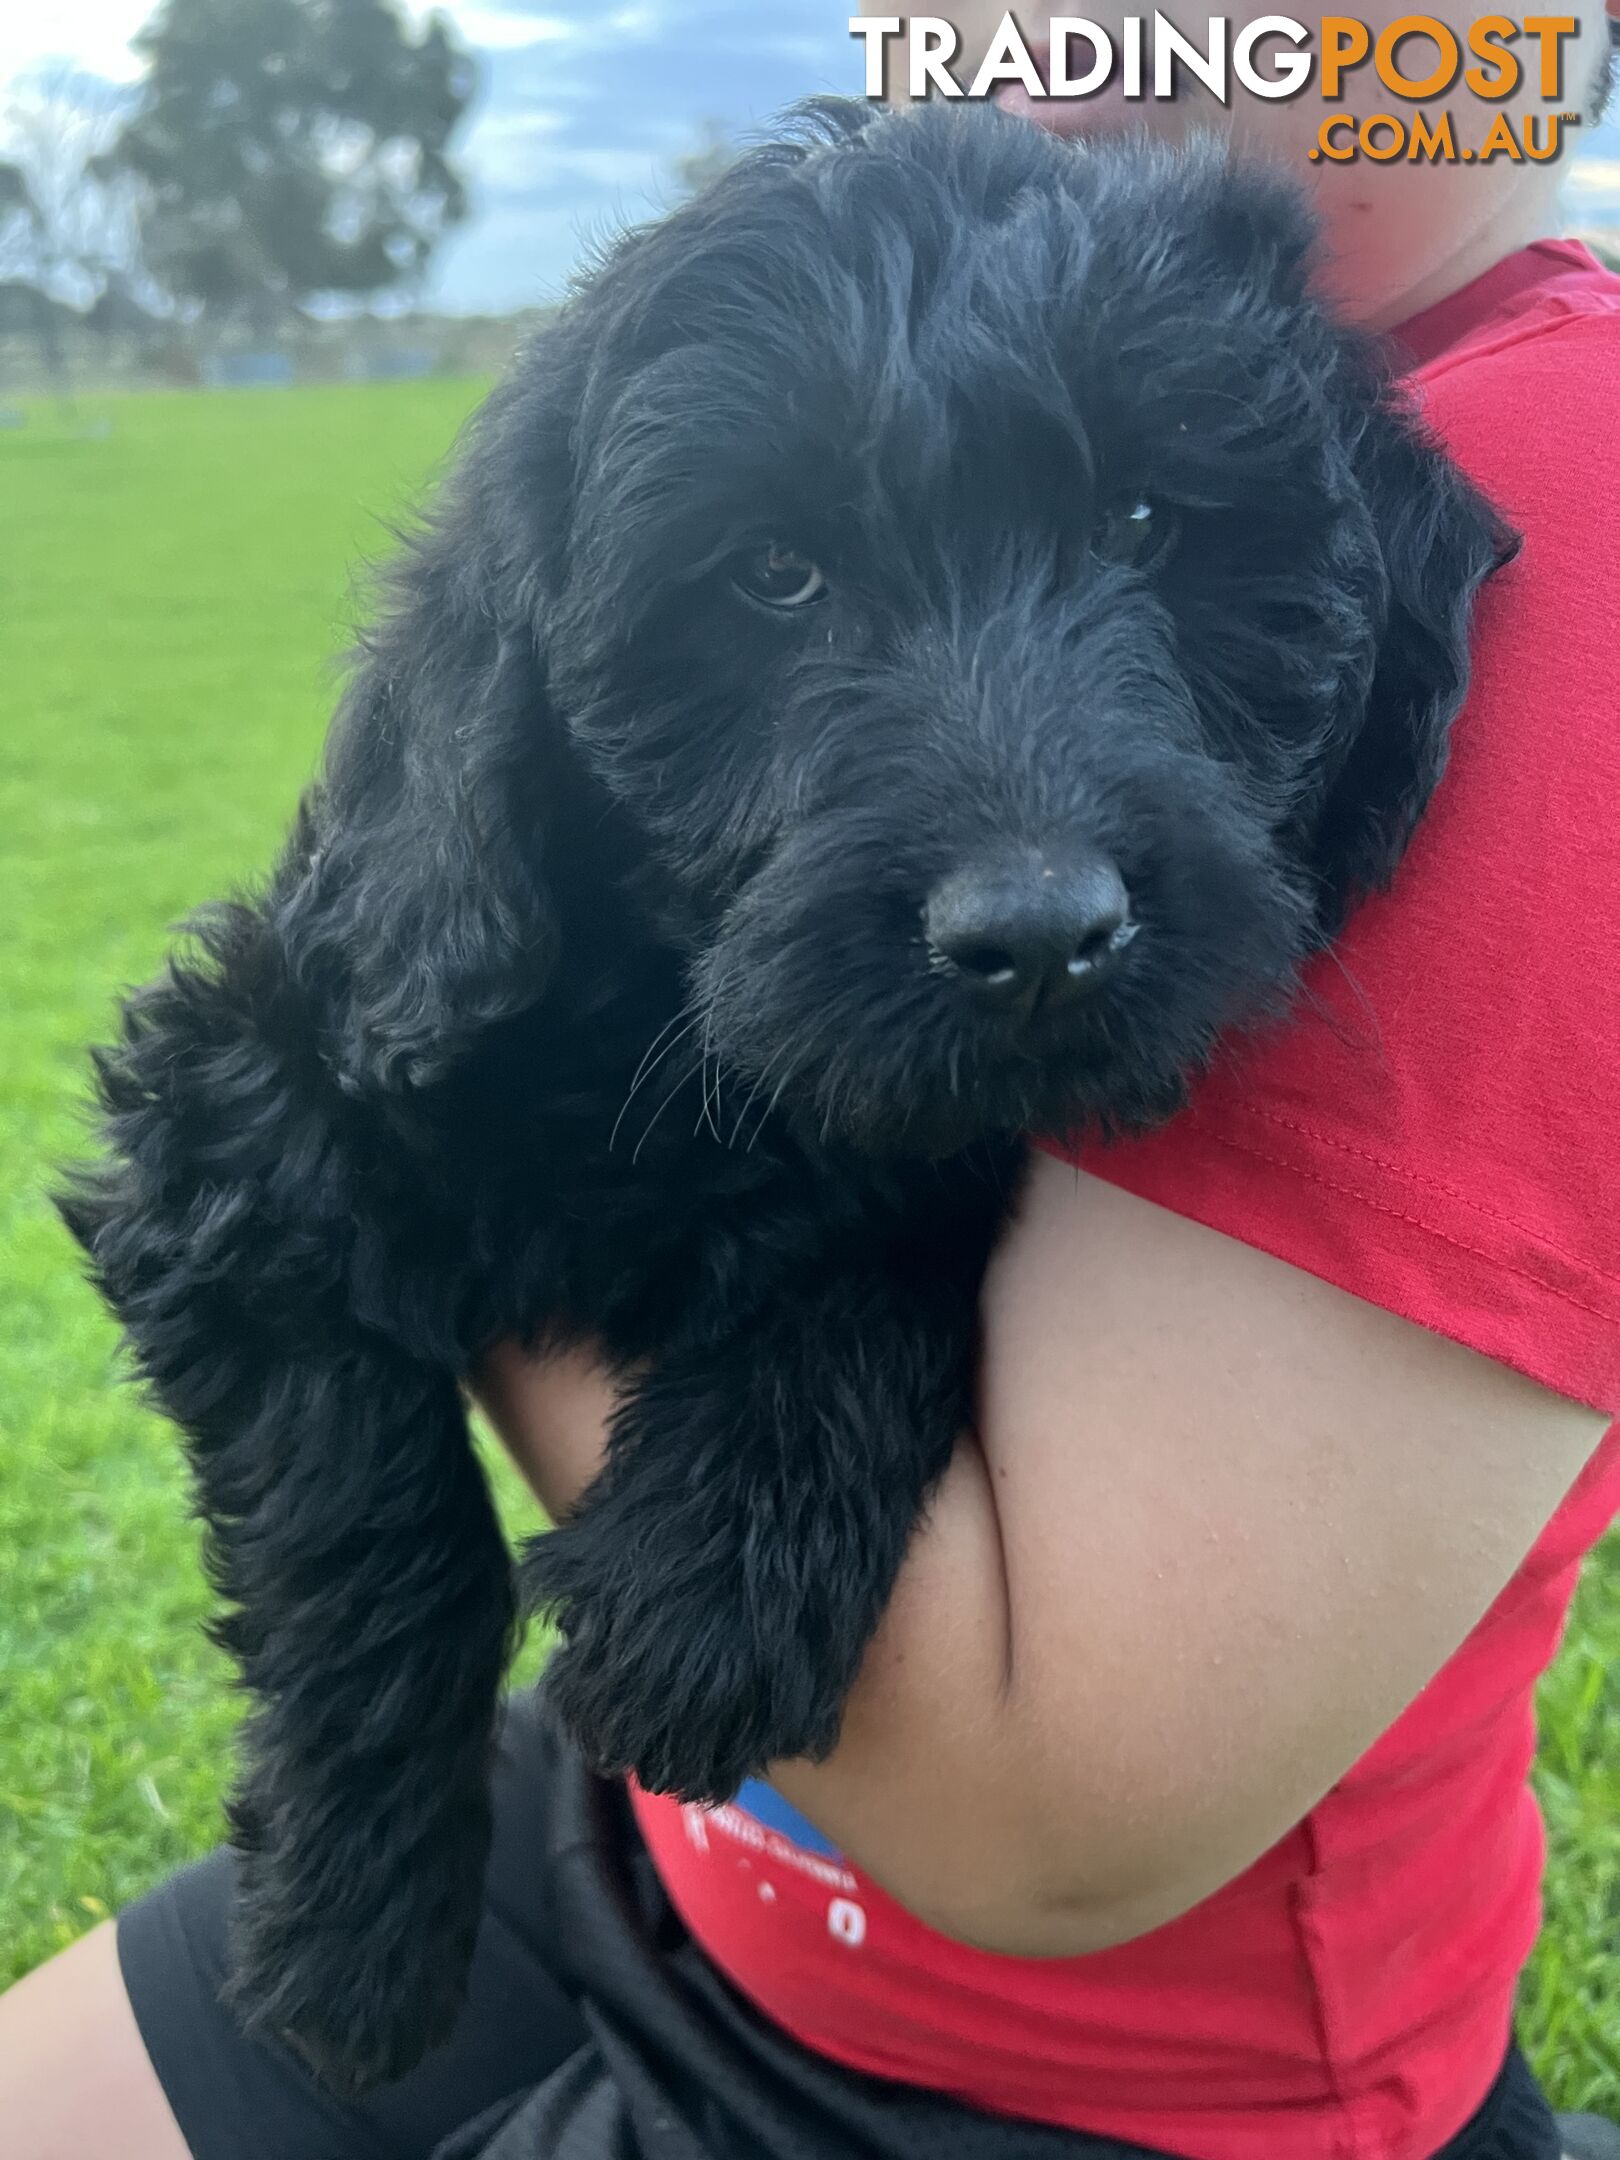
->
[635,242,1620,2160]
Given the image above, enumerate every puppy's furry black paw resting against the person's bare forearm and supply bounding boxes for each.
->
[525,1510,842,1801]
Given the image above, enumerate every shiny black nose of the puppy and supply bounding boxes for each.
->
[922,855,1136,1017]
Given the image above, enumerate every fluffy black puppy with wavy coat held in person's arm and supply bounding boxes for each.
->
[65,106,1510,2084]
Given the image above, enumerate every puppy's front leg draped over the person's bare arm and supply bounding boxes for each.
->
[525,1266,978,1799]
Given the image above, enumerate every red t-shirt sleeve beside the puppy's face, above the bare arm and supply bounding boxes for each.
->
[1045,311,1620,1410]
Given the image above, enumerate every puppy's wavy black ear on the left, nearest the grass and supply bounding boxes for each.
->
[289,529,557,1093]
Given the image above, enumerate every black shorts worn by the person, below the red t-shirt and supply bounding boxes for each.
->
[119,1696,1557,2160]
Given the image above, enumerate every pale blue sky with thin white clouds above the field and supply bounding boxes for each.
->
[0,0,1620,311]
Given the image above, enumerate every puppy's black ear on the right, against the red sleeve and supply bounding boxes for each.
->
[1307,378,1518,937]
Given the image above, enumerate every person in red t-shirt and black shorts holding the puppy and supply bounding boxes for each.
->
[0,4,1620,2160]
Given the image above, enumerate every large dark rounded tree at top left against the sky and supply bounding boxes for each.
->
[108,0,475,328]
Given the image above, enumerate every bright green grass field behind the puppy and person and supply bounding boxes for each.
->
[0,384,1620,2115]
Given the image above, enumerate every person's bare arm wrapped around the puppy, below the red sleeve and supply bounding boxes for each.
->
[475,1158,1607,1957]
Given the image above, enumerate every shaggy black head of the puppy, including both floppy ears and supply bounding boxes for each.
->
[302,106,1508,1151]
